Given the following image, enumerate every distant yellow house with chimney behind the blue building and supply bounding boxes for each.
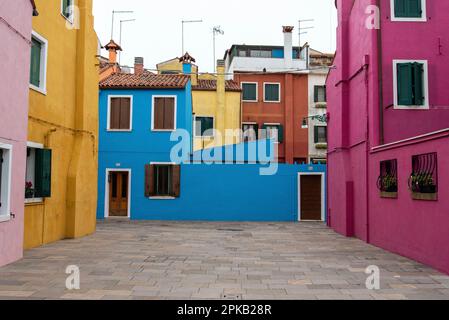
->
[157,53,242,151]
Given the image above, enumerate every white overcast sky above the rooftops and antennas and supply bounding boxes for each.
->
[94,0,337,72]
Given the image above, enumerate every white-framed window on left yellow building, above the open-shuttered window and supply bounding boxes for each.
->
[30,31,48,94]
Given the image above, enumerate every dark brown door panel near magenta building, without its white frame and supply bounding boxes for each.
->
[300,175,322,221]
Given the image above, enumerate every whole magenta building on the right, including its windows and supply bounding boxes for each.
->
[327,0,449,273]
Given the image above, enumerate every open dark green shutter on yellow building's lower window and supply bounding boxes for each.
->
[35,149,52,198]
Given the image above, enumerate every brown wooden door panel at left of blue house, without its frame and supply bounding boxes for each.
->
[109,172,129,217]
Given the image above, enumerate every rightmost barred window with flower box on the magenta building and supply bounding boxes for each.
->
[409,153,438,200]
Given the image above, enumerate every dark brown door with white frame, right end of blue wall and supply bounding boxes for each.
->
[298,173,325,221]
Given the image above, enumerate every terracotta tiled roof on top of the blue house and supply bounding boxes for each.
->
[100,71,190,89]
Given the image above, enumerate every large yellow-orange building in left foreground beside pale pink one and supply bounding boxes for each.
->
[24,0,98,249]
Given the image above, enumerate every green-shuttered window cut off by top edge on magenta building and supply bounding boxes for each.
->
[391,0,427,21]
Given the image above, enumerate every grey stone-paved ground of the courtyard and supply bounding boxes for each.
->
[0,221,449,300]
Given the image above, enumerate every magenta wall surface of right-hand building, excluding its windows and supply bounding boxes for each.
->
[327,0,449,273]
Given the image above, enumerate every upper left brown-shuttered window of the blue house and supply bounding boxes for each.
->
[108,96,132,131]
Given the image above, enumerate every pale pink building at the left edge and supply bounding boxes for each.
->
[0,0,37,266]
